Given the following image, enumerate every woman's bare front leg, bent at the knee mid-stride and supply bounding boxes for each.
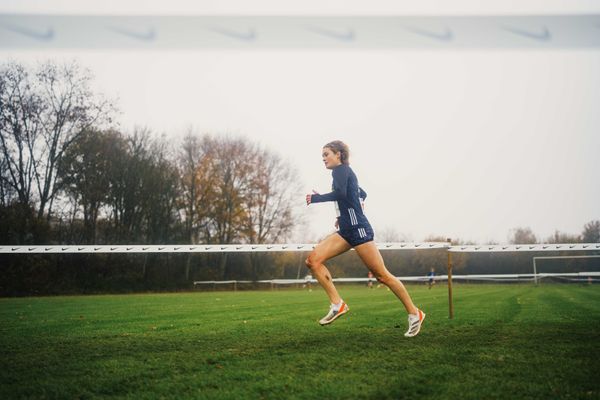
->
[306,233,350,304]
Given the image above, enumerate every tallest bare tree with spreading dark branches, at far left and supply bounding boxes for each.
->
[0,62,114,225]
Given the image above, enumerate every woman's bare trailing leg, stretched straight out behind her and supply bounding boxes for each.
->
[354,242,417,314]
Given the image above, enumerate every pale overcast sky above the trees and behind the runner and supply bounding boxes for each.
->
[0,1,600,243]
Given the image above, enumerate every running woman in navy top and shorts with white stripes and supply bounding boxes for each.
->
[306,140,425,337]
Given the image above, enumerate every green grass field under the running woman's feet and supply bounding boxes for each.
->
[0,285,600,399]
